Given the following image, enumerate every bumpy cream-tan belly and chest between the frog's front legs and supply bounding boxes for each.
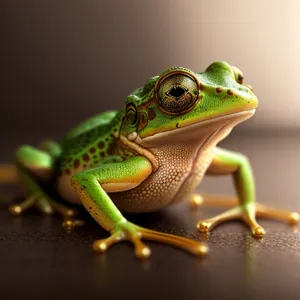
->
[110,146,213,212]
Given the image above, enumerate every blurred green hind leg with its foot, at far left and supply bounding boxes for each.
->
[9,145,79,228]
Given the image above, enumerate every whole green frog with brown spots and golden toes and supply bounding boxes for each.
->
[0,61,299,259]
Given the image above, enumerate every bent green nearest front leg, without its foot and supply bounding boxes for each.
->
[71,156,152,231]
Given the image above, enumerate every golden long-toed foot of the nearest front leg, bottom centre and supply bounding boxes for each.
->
[93,221,208,259]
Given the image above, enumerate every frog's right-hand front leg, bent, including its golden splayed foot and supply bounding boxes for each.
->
[193,148,299,237]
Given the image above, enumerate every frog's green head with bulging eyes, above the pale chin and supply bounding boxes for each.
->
[122,62,258,144]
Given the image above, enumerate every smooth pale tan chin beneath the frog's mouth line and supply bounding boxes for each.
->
[135,109,255,148]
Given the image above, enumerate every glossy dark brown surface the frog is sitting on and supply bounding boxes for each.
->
[0,132,300,299]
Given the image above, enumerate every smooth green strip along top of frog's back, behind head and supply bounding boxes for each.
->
[62,111,118,145]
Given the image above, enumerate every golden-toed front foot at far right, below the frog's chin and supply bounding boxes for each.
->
[197,193,299,237]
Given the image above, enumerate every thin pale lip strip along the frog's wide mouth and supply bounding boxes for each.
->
[136,108,256,144]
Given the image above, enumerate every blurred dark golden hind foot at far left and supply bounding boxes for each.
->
[8,193,83,229]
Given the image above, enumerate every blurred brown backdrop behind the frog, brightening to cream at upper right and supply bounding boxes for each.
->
[0,0,300,142]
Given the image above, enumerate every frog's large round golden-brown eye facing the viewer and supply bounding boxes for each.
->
[156,73,199,114]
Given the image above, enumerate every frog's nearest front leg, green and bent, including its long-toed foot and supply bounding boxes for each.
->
[71,156,208,258]
